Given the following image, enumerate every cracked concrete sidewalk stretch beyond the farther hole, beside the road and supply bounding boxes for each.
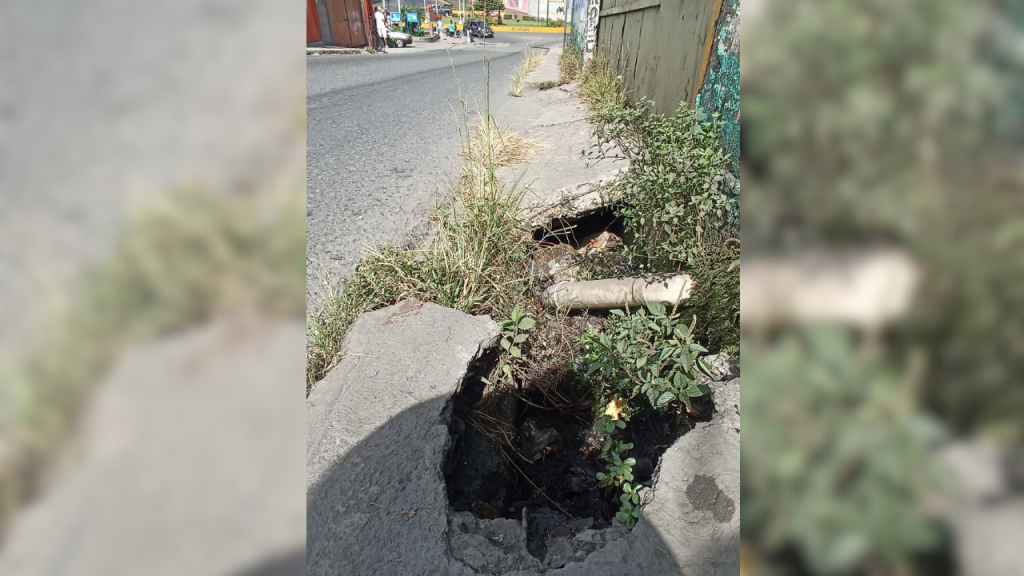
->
[496,47,629,227]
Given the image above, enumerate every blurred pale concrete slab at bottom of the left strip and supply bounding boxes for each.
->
[0,319,305,576]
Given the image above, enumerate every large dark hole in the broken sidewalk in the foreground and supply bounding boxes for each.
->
[443,364,692,567]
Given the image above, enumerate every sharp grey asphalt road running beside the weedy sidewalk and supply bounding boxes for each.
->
[306,33,562,313]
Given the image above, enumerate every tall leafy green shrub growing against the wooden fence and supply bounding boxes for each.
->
[594,96,739,355]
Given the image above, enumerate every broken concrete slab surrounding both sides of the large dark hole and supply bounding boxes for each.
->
[306,301,739,576]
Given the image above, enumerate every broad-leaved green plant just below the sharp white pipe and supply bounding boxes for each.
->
[581,302,711,411]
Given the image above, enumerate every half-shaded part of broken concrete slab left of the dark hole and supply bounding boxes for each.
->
[306,300,499,575]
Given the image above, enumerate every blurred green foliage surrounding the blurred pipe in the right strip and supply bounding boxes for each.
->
[742,0,1024,572]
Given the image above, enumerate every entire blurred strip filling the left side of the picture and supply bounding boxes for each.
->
[0,0,305,576]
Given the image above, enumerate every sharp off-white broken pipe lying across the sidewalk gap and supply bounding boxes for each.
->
[541,274,693,310]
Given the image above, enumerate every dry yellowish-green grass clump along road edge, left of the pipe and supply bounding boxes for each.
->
[306,170,530,387]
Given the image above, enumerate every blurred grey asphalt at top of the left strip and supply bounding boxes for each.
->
[0,0,305,344]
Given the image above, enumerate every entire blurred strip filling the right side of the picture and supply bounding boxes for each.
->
[741,0,1024,576]
